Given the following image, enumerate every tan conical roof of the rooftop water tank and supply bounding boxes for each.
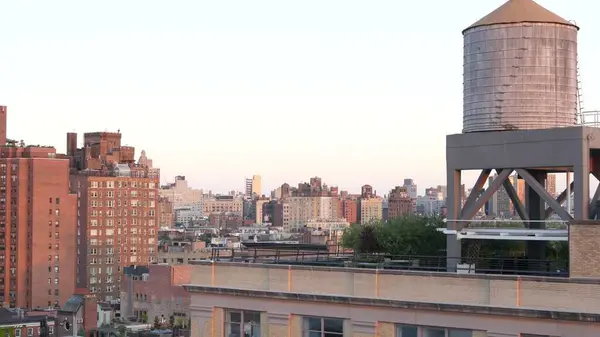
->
[463,0,579,33]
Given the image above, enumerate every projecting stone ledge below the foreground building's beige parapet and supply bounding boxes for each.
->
[183,284,600,323]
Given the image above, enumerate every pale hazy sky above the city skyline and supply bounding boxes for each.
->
[0,0,600,194]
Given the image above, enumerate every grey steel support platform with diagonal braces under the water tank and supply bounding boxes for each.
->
[446,126,600,269]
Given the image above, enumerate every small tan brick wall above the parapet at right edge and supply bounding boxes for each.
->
[569,221,600,278]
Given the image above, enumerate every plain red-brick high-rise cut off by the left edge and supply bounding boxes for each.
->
[0,107,77,308]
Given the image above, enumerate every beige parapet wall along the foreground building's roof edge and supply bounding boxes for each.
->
[190,262,600,314]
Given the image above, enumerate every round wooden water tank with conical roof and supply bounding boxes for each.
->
[463,0,579,133]
